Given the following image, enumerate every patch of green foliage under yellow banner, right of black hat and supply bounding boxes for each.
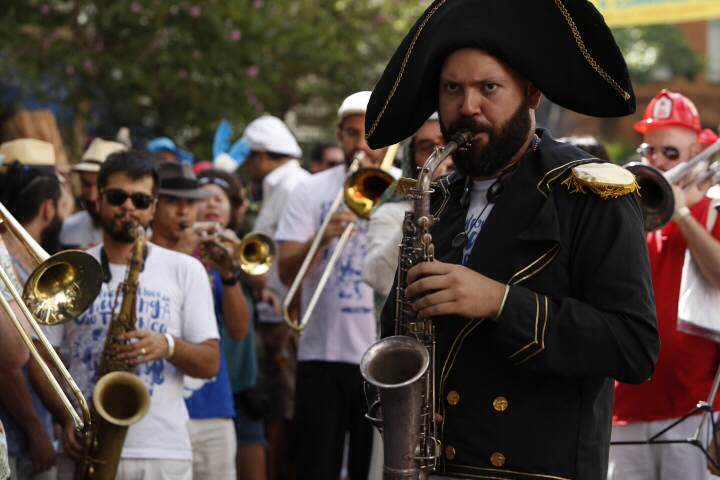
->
[613,25,703,83]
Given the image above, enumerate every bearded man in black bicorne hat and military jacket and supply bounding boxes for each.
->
[366,0,659,480]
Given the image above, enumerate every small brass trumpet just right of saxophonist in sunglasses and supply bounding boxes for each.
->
[193,222,276,276]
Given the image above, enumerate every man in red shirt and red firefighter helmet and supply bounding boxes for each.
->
[608,90,720,480]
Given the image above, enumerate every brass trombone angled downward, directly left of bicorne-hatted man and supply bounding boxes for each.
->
[282,144,398,333]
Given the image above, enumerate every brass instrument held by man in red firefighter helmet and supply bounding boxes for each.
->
[624,140,720,232]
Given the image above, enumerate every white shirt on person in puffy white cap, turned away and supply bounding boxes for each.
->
[253,160,310,323]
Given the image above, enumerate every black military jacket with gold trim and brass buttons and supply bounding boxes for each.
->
[383,130,659,480]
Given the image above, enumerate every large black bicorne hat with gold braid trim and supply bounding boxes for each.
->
[365,0,635,148]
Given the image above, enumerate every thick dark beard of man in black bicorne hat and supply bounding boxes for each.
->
[440,99,532,177]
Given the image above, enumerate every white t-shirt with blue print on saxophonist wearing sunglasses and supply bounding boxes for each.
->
[45,244,219,460]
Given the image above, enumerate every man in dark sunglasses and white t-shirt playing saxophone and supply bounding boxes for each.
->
[45,151,220,479]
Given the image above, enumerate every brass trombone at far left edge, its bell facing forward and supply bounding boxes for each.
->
[0,203,102,436]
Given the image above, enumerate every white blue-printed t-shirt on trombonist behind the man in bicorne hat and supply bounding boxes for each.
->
[276,165,376,364]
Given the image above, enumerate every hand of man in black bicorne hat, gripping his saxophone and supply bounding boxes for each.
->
[405,261,507,318]
